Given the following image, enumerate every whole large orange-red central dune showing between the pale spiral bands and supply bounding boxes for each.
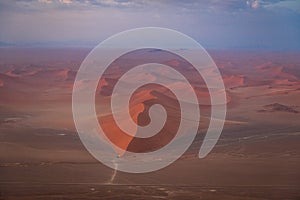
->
[99,84,180,153]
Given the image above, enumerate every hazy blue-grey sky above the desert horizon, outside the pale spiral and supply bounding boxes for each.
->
[0,0,300,50]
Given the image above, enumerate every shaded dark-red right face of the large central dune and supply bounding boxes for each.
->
[127,84,181,152]
